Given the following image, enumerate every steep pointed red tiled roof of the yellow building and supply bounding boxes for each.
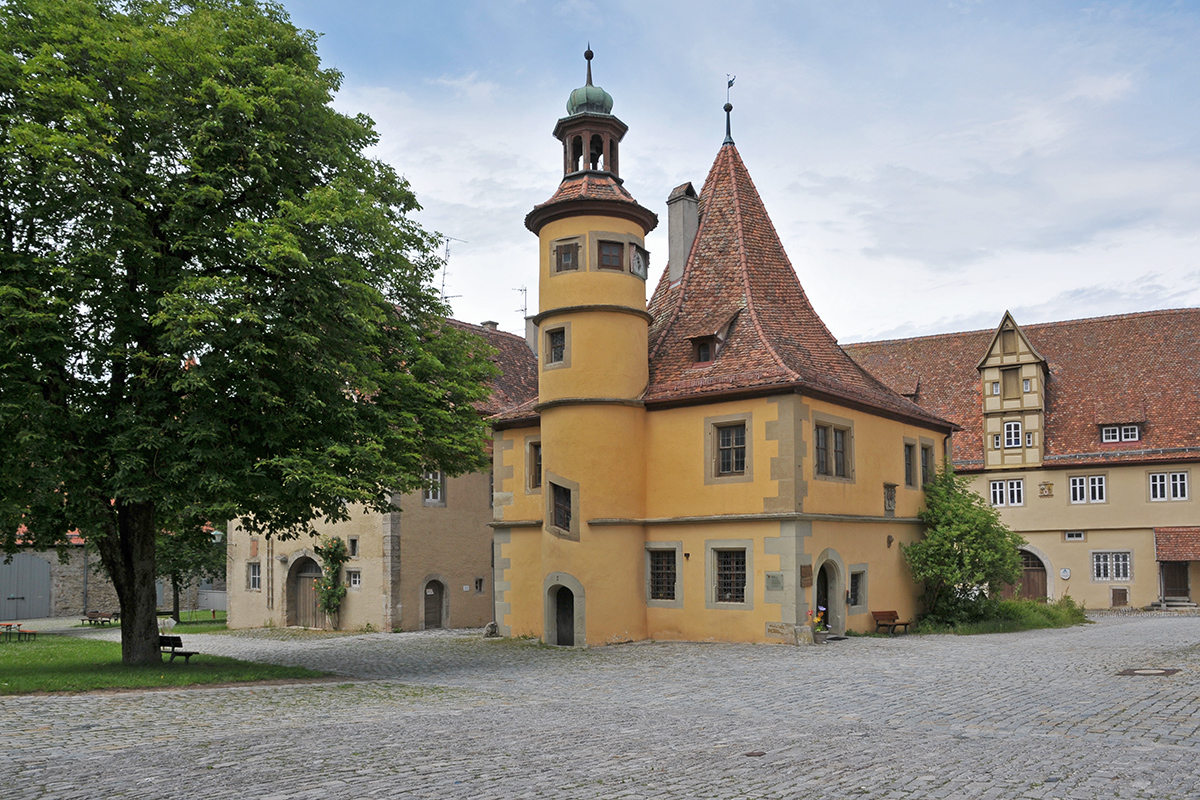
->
[646,144,948,427]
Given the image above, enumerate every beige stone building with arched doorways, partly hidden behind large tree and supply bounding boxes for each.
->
[227,320,536,631]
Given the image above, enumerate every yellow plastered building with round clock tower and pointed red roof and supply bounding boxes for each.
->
[492,52,954,646]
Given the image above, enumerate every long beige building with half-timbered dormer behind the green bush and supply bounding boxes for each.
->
[846,308,1200,608]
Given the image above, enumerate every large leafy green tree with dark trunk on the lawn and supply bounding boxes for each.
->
[0,0,492,663]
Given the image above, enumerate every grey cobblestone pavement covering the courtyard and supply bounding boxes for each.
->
[0,616,1200,800]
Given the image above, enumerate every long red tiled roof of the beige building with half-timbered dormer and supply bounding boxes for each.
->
[846,308,1200,469]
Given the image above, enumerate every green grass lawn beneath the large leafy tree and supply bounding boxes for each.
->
[0,627,325,694]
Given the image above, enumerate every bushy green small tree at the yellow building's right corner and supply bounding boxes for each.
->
[902,464,1025,625]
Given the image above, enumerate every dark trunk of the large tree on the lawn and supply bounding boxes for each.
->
[96,500,162,664]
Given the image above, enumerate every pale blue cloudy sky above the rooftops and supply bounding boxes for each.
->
[274,0,1200,342]
